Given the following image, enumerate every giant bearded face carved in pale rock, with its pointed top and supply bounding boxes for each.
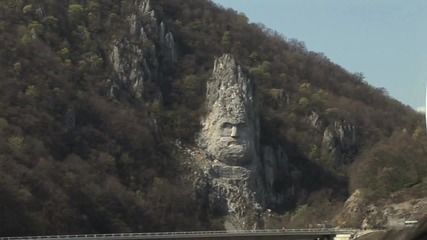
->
[198,54,258,166]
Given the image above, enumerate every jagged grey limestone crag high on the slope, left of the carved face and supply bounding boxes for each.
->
[106,0,177,100]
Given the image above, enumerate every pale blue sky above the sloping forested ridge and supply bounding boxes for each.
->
[212,0,427,111]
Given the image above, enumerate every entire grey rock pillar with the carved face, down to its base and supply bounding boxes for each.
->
[197,54,288,229]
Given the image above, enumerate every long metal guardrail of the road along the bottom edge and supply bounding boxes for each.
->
[0,228,360,240]
